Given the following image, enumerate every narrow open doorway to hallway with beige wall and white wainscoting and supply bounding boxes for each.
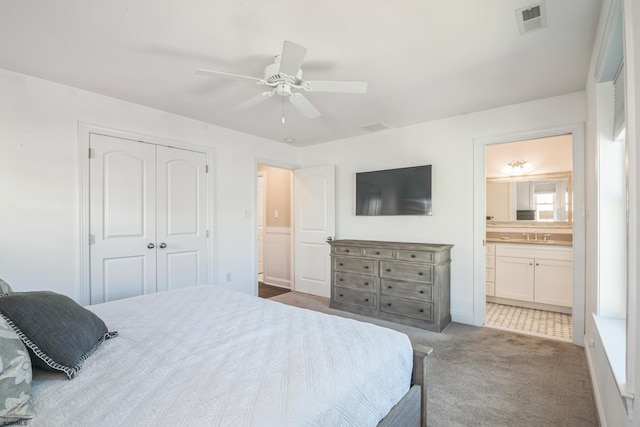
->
[256,164,293,298]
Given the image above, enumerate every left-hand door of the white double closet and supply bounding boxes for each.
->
[89,134,156,304]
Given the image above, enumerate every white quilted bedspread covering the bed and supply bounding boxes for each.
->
[29,286,413,427]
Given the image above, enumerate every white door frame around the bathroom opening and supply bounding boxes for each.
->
[473,122,586,346]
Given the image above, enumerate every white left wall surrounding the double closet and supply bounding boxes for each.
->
[0,69,297,300]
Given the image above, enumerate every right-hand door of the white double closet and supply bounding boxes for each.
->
[156,146,207,291]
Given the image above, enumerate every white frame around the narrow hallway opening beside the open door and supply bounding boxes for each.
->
[251,157,300,295]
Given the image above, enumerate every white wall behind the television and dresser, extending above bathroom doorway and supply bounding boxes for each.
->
[301,92,586,324]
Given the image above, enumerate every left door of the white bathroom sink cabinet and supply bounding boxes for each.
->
[496,257,534,301]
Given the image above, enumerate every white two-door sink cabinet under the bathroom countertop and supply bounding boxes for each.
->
[495,244,573,307]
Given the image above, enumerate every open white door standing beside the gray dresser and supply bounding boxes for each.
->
[294,165,336,298]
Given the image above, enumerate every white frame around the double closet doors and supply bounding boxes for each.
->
[77,121,217,305]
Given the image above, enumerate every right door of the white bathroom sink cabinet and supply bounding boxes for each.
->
[534,259,573,307]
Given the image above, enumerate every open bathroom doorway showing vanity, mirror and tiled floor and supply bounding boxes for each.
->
[484,134,574,342]
